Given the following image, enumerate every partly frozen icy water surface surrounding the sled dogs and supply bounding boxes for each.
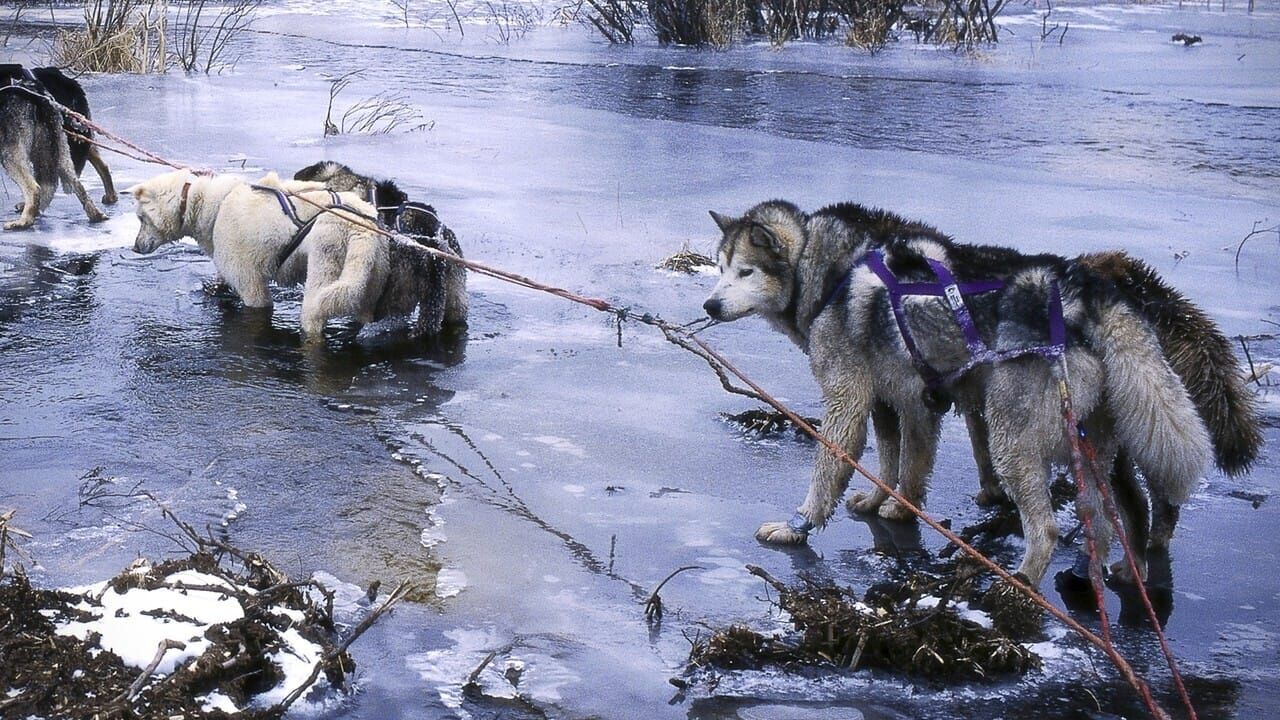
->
[0,5,1280,719]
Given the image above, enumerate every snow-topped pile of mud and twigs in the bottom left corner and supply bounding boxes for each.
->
[0,552,355,719]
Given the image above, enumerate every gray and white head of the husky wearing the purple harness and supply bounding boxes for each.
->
[703,201,804,322]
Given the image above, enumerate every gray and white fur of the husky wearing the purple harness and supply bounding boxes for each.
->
[705,201,1210,584]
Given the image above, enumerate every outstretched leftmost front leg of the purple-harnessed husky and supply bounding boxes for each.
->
[755,377,870,544]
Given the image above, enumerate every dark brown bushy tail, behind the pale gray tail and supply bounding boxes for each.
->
[1080,252,1262,475]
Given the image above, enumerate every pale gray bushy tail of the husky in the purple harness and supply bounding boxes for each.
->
[1085,299,1211,505]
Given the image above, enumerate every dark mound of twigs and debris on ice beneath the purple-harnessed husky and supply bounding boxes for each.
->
[689,565,1041,682]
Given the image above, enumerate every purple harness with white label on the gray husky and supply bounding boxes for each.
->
[814,250,1066,389]
